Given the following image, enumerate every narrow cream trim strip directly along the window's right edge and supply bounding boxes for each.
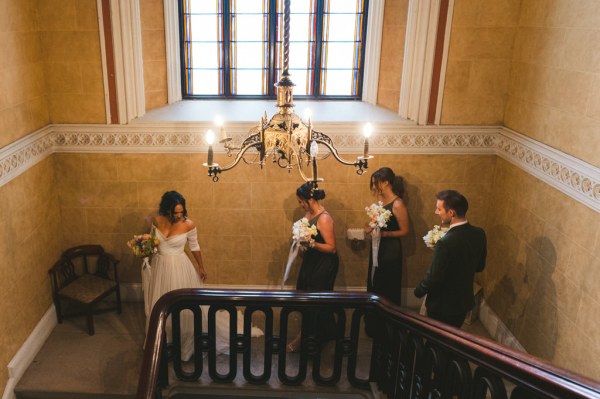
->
[362,0,385,105]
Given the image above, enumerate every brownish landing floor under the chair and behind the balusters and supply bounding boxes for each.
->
[15,303,487,399]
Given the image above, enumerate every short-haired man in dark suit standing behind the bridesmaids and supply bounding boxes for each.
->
[415,190,487,328]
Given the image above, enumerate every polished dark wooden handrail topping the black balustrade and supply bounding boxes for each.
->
[136,289,600,399]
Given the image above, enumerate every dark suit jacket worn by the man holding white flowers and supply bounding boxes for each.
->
[415,223,487,315]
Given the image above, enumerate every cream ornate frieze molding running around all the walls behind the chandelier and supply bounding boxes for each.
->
[0,122,600,212]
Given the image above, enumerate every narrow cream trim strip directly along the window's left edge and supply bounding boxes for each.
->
[164,0,181,104]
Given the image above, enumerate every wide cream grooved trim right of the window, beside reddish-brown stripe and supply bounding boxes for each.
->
[398,0,440,125]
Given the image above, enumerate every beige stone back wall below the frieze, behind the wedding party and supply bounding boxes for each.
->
[54,154,495,288]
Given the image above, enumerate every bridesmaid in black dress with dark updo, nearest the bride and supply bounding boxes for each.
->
[286,183,339,352]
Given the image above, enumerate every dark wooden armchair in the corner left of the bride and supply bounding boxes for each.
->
[48,245,121,335]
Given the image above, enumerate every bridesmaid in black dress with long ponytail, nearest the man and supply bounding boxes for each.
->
[366,167,410,305]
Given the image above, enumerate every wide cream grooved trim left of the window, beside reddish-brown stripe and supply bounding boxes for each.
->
[110,0,146,124]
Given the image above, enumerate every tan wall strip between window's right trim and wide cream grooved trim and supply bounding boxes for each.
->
[377,0,408,112]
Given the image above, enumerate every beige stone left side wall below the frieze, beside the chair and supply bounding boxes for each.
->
[0,158,62,387]
